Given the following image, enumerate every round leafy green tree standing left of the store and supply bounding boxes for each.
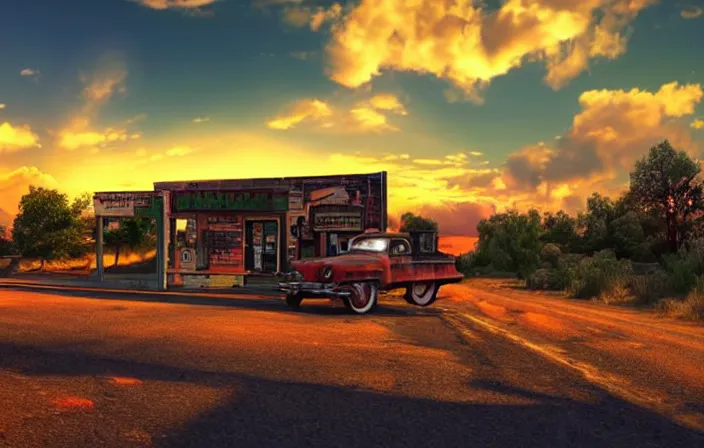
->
[12,186,89,269]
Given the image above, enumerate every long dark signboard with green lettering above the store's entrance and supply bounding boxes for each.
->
[172,191,288,213]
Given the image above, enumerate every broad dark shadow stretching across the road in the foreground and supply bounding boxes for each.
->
[0,344,704,448]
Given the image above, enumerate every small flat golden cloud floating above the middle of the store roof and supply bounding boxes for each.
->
[267,94,407,133]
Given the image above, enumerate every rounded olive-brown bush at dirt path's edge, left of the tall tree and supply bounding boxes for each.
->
[568,250,632,299]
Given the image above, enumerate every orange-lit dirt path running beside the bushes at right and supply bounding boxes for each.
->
[439,279,704,429]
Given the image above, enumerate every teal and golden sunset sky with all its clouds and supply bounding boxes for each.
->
[0,0,704,235]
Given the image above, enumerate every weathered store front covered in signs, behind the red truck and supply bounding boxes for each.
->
[154,172,387,287]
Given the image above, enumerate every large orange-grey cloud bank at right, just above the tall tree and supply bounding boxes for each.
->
[478,82,704,214]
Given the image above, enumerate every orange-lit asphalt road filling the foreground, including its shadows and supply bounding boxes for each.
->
[0,288,704,448]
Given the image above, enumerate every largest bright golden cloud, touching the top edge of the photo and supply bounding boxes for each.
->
[327,0,656,101]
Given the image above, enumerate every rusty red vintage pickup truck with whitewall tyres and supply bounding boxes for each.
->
[279,231,463,314]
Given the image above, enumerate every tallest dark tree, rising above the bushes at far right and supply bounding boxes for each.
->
[630,140,704,252]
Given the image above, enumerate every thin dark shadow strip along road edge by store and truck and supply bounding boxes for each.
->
[0,285,424,316]
